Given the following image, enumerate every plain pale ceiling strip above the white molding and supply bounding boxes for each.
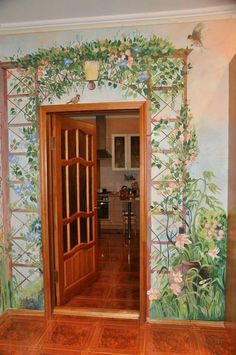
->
[0,0,236,26]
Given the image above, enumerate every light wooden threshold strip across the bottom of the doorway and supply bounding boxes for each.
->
[53,307,140,320]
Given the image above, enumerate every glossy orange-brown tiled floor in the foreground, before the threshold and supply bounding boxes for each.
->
[0,316,236,355]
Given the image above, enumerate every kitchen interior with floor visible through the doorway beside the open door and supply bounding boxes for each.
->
[65,110,140,312]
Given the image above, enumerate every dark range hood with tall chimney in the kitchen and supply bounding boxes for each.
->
[96,115,111,160]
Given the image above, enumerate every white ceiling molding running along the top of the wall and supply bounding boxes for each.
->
[0,5,236,35]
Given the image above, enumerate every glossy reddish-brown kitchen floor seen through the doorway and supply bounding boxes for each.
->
[64,231,139,310]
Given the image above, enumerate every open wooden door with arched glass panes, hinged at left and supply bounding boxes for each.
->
[52,114,97,306]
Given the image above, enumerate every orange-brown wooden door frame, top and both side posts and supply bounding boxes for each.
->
[39,101,150,321]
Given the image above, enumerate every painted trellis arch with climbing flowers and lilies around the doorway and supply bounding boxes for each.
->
[1,32,227,320]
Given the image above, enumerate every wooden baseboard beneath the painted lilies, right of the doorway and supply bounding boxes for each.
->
[147,318,225,328]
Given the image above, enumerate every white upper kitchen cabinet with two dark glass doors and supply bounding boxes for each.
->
[112,134,139,170]
